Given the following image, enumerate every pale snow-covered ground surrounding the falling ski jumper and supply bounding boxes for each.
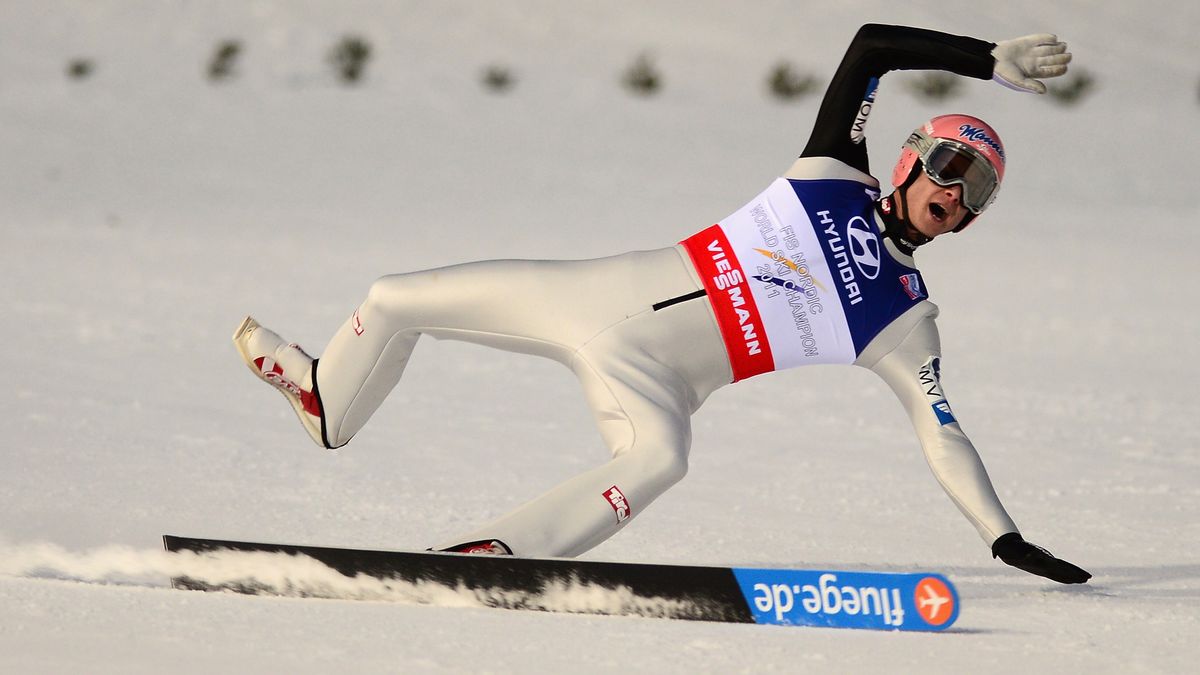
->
[0,0,1200,674]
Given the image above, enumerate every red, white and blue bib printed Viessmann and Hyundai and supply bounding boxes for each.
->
[682,178,925,382]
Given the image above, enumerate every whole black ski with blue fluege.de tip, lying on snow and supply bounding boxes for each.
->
[163,536,959,631]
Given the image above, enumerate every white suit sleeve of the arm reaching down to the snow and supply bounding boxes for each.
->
[857,301,1018,546]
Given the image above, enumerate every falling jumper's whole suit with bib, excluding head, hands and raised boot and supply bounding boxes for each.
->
[304,25,1016,556]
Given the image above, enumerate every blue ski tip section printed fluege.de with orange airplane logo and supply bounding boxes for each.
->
[733,568,959,631]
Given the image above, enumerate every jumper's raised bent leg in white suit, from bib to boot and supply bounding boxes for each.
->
[316,247,697,447]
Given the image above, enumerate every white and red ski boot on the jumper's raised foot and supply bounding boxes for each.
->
[233,316,329,448]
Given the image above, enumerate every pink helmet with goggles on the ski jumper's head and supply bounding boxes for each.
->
[892,114,1004,229]
